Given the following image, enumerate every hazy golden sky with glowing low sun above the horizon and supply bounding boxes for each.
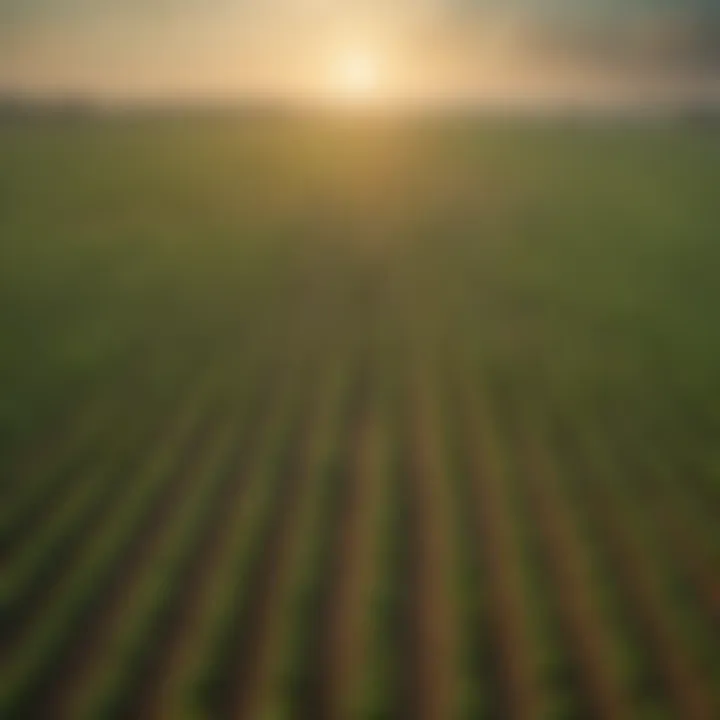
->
[0,0,720,104]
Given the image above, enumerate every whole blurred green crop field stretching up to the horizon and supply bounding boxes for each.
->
[0,116,720,720]
